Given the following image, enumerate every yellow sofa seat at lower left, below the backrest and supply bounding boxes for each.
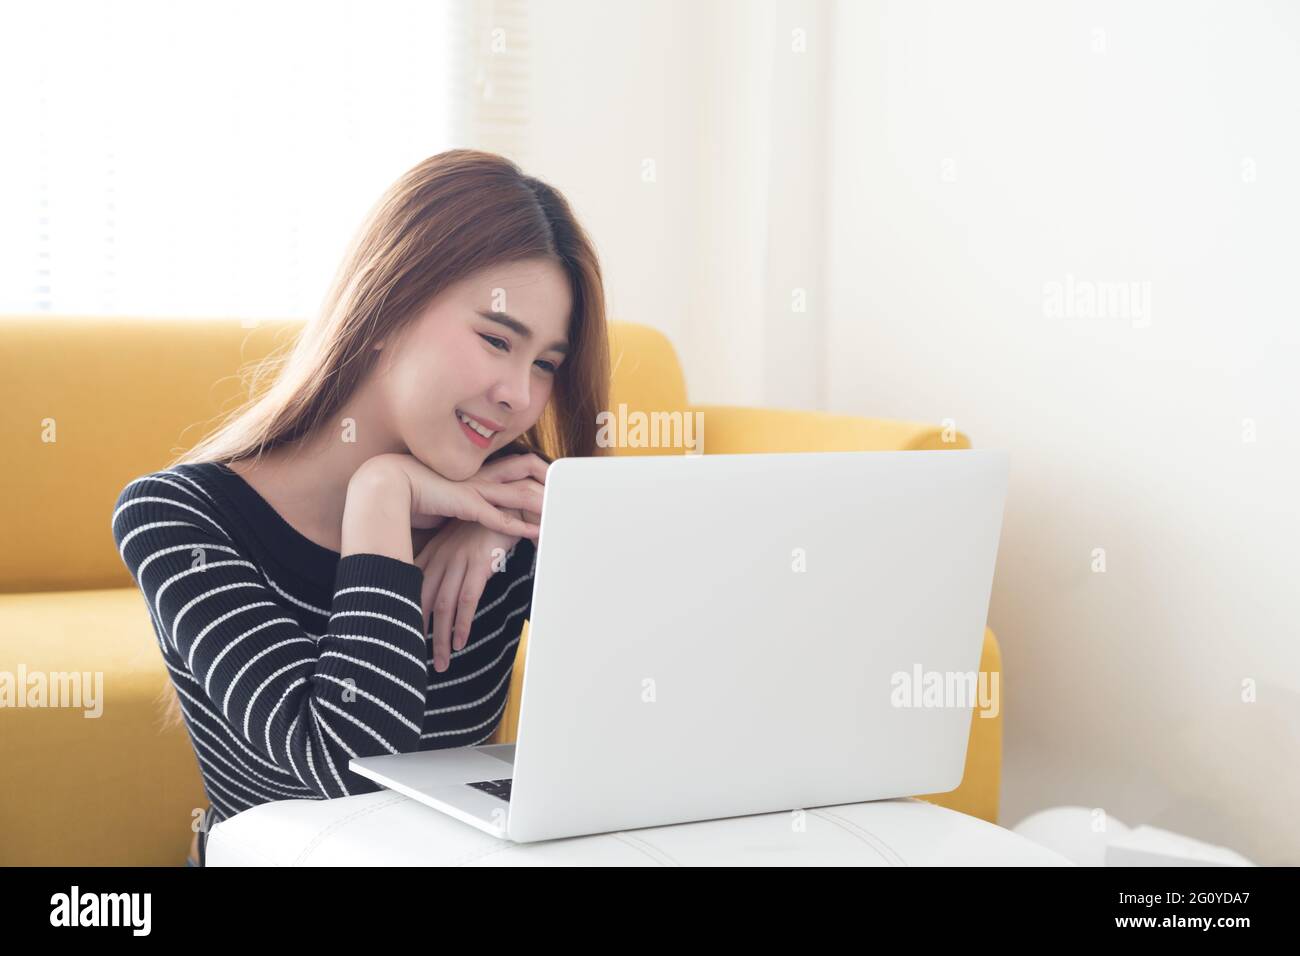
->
[0,588,207,866]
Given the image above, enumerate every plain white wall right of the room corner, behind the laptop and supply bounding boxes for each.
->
[827,0,1300,865]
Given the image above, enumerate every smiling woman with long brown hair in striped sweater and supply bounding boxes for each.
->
[113,150,610,866]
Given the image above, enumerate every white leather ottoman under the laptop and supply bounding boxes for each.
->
[207,791,1074,866]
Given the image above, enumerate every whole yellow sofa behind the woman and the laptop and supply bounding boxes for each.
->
[0,316,1002,866]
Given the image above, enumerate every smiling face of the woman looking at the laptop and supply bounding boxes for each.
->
[380,260,572,481]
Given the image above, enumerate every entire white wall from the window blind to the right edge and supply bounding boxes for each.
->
[529,0,1300,864]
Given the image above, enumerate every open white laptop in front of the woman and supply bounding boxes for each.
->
[348,449,1008,843]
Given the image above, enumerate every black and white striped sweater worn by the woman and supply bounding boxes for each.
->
[113,462,537,839]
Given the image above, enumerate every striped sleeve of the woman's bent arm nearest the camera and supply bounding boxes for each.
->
[113,475,428,797]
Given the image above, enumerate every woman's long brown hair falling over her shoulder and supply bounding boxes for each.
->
[156,150,610,726]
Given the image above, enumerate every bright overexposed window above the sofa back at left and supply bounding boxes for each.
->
[0,0,489,317]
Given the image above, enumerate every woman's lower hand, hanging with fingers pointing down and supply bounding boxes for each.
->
[415,512,520,674]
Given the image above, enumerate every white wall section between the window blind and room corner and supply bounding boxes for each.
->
[528,0,831,408]
